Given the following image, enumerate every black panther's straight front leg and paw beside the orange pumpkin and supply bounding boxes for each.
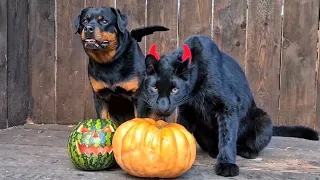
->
[215,112,239,177]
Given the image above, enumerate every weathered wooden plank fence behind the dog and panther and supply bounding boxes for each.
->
[0,0,320,130]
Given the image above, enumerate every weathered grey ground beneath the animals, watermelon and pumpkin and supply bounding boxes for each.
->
[0,125,320,180]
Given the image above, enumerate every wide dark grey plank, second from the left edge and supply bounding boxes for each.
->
[7,0,31,127]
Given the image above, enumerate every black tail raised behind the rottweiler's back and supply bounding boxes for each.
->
[130,26,169,42]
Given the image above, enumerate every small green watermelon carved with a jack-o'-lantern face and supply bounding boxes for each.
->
[68,119,116,170]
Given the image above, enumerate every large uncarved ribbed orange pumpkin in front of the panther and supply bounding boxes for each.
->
[112,118,196,178]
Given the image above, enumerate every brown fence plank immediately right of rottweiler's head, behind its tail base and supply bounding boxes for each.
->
[117,0,146,53]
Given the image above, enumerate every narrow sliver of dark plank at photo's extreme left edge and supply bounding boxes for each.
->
[0,0,8,129]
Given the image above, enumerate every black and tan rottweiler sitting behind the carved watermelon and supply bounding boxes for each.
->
[74,7,169,125]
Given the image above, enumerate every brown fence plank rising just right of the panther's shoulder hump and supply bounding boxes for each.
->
[213,0,247,68]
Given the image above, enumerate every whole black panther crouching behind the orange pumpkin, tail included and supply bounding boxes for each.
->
[138,35,319,176]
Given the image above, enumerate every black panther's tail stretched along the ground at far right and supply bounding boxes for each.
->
[272,126,319,141]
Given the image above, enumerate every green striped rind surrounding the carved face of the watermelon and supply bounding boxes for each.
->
[67,119,117,171]
